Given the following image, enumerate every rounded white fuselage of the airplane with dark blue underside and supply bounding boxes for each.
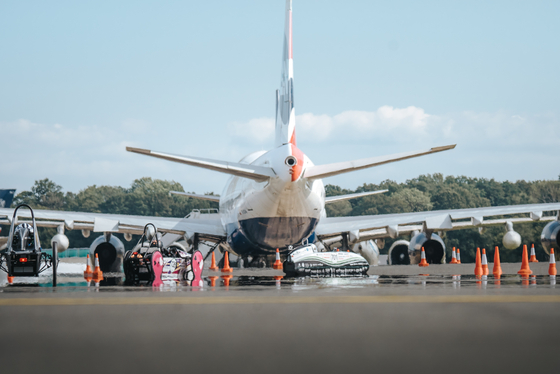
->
[220,143,326,256]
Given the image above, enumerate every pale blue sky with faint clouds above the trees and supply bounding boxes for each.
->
[0,0,560,193]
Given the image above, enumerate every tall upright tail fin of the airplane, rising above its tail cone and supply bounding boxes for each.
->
[275,0,296,147]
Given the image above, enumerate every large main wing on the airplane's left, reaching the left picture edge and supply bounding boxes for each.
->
[0,208,226,241]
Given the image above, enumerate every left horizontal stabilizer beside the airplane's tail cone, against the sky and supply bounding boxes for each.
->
[126,147,275,182]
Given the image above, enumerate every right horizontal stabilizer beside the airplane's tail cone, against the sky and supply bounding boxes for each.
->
[304,144,456,179]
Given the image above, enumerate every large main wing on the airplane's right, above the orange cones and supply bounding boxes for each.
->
[315,203,560,240]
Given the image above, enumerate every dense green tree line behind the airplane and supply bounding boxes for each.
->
[5,174,560,262]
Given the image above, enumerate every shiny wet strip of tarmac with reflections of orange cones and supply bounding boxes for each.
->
[0,273,556,292]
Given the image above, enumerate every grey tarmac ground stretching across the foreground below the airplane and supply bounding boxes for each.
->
[0,263,560,374]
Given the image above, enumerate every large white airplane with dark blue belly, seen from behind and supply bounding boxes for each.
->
[0,0,560,271]
